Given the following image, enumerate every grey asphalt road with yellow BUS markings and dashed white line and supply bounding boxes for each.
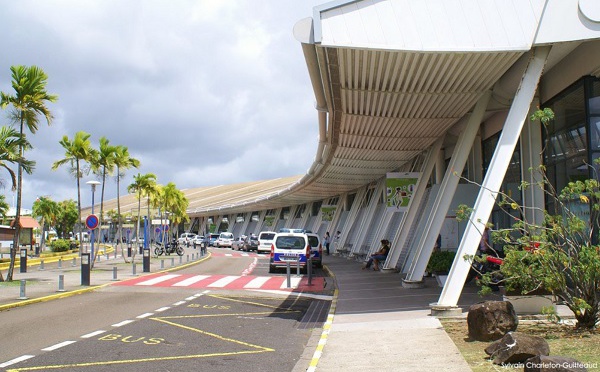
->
[0,251,324,372]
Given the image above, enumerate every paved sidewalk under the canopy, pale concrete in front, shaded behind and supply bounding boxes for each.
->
[308,256,501,372]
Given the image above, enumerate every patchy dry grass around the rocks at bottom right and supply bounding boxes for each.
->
[440,319,600,372]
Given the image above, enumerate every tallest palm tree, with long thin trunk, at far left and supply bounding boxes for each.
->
[0,66,58,281]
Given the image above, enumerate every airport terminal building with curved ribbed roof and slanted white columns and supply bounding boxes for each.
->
[95,0,600,307]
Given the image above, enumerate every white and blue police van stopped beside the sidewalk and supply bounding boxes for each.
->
[269,233,312,273]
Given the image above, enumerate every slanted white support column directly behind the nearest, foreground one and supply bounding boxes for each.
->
[405,91,492,282]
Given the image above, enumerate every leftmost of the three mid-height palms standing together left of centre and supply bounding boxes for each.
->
[52,131,95,247]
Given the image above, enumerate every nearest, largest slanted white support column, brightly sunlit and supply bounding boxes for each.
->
[432,46,551,314]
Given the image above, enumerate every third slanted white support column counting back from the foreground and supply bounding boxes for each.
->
[385,136,445,267]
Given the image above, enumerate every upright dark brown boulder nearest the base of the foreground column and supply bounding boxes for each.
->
[467,301,519,341]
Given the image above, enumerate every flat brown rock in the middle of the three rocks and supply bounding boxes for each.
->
[485,332,550,364]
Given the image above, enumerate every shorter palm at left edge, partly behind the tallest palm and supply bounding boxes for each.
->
[0,127,35,282]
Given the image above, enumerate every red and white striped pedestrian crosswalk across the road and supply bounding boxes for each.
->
[114,273,324,291]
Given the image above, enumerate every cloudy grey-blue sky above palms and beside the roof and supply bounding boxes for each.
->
[0,0,326,209]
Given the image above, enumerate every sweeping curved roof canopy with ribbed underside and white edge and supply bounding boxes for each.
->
[90,0,600,217]
